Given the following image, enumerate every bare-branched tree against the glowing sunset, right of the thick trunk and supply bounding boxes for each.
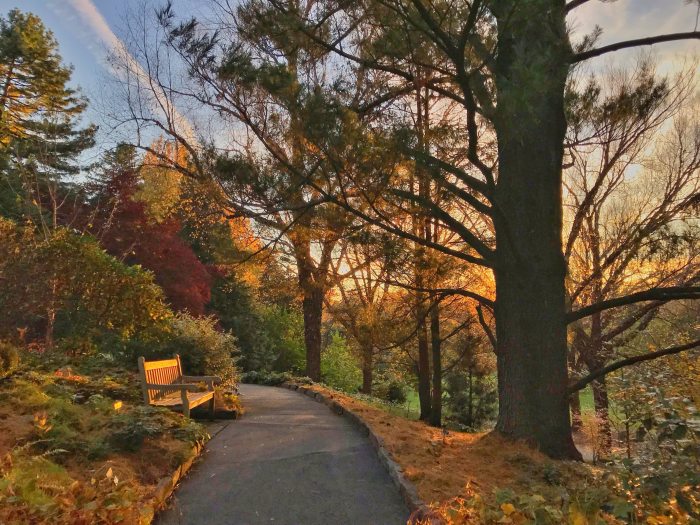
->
[564,61,700,450]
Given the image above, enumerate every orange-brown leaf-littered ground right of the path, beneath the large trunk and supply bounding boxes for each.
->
[296,384,700,525]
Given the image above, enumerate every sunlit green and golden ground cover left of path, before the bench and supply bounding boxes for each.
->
[0,348,209,524]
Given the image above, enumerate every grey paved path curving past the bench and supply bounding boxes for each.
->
[158,385,408,525]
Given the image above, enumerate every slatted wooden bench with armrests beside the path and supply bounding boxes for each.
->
[139,355,221,418]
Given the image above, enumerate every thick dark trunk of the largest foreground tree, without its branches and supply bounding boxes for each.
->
[494,0,581,459]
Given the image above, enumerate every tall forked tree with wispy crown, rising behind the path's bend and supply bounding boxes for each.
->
[116,0,394,379]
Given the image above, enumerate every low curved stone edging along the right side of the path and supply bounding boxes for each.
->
[279,383,430,519]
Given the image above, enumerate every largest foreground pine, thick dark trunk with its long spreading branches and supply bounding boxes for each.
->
[277,0,700,458]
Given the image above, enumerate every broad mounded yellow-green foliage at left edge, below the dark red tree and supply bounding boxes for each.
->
[0,219,171,343]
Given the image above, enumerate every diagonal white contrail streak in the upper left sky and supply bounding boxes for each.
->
[67,0,195,143]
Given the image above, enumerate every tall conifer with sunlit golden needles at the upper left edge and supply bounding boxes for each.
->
[0,9,97,180]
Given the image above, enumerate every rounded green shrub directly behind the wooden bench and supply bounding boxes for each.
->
[161,314,238,388]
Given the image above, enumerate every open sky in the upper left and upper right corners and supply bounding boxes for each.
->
[0,0,700,156]
